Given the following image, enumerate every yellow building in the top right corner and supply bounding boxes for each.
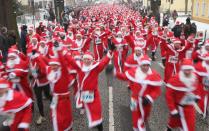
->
[192,0,209,24]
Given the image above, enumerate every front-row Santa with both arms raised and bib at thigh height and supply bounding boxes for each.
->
[65,45,115,131]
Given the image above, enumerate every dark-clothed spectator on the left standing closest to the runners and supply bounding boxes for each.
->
[20,25,27,54]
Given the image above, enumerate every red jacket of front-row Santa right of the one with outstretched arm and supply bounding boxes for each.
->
[166,73,200,114]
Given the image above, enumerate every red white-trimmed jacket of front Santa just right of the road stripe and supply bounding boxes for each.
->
[116,67,162,102]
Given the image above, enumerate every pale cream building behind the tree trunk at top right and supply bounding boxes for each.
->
[160,0,192,12]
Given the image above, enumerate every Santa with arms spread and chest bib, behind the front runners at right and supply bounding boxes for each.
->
[161,38,192,82]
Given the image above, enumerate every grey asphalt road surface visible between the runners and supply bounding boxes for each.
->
[1,50,209,131]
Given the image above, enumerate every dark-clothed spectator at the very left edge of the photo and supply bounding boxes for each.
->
[0,27,8,62]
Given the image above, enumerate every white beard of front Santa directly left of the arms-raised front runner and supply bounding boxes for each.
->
[47,69,61,83]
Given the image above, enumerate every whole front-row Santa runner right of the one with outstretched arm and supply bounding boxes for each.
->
[166,59,200,131]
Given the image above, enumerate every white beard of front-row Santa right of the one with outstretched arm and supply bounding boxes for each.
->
[179,71,196,88]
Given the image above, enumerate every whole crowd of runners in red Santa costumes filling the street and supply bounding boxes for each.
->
[0,4,209,131]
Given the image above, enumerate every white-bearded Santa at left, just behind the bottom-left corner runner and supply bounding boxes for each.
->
[6,48,33,98]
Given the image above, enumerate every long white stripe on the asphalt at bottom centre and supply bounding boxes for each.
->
[109,86,115,131]
